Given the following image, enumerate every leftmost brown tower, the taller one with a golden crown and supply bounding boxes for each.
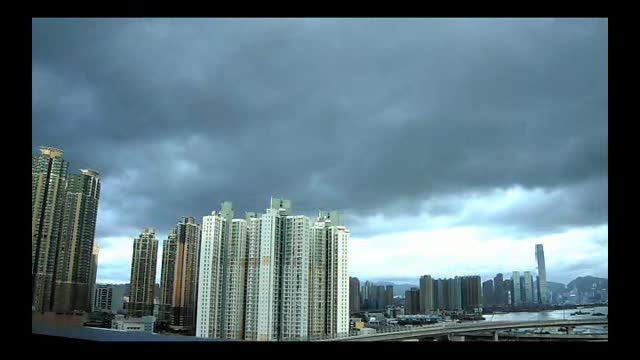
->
[31,146,69,312]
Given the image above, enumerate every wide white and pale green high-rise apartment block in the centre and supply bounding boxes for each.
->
[196,199,350,341]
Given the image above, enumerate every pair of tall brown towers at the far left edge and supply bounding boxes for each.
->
[31,146,100,312]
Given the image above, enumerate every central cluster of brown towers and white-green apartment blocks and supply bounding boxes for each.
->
[129,199,350,341]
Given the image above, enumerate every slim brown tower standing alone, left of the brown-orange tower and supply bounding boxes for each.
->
[128,228,158,317]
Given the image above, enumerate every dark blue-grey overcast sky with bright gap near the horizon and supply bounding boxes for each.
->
[31,19,609,283]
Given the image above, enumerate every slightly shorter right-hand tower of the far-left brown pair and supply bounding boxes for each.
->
[54,170,100,312]
